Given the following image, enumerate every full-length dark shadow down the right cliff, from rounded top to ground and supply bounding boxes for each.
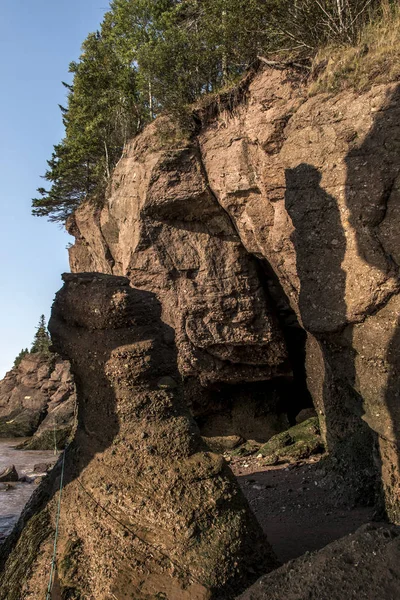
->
[285,164,375,503]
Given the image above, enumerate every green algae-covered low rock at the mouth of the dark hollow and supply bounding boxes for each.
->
[258,417,324,464]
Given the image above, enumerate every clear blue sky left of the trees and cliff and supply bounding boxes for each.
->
[0,0,108,378]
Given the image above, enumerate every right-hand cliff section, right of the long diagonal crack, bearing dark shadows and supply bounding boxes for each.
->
[200,71,400,522]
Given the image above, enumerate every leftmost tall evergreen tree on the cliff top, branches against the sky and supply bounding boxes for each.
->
[32,20,142,221]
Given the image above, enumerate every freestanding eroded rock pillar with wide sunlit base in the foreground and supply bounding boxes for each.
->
[0,274,276,600]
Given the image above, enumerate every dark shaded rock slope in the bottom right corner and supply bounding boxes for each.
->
[238,524,400,600]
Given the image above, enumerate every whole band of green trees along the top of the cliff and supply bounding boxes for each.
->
[33,0,394,221]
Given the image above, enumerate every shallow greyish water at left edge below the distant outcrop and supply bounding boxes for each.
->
[0,438,57,544]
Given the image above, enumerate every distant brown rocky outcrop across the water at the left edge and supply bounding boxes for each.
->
[0,353,76,450]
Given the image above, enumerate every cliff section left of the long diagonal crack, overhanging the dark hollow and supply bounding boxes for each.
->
[69,120,290,385]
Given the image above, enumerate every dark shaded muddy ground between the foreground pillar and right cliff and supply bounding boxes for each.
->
[228,456,374,563]
